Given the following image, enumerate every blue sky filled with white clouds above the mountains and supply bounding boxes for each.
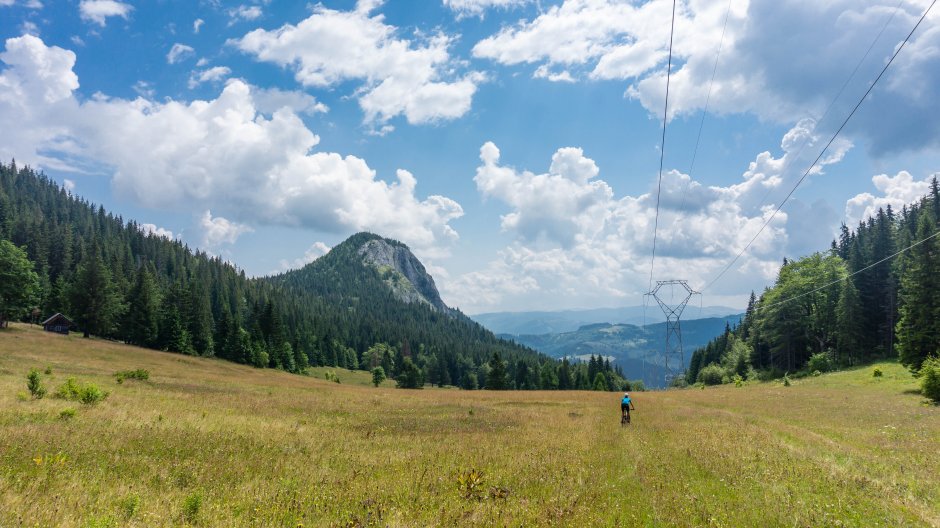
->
[0,0,940,314]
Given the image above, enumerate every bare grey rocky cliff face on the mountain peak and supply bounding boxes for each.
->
[359,238,451,313]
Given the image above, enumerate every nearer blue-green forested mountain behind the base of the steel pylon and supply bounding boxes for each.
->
[501,314,743,387]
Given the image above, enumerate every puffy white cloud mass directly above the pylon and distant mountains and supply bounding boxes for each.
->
[441,120,851,312]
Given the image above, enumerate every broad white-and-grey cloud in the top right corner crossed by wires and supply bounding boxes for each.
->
[473,0,940,154]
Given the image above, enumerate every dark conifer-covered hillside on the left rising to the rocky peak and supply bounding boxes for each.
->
[0,163,559,388]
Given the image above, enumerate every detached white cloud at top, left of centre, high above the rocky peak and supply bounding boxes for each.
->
[234,2,484,128]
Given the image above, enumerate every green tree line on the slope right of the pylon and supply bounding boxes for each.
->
[680,177,940,384]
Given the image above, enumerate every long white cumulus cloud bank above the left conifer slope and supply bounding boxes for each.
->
[0,35,463,255]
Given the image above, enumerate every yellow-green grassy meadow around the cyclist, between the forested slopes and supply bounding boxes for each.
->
[0,325,940,527]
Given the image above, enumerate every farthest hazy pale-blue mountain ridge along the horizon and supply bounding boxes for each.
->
[470,305,741,335]
